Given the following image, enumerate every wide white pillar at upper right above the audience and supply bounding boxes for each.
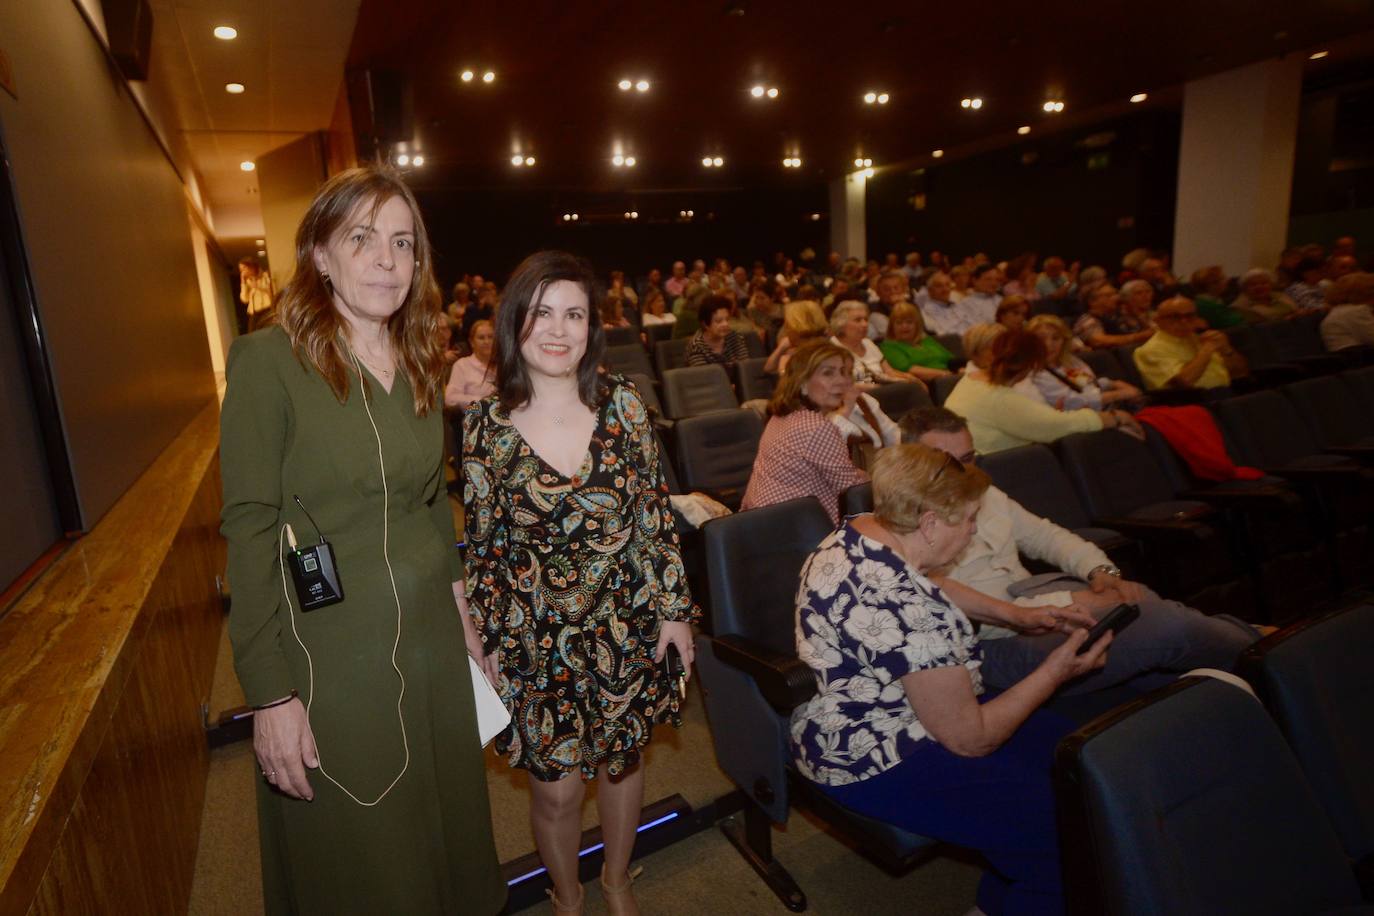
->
[1173,55,1303,276]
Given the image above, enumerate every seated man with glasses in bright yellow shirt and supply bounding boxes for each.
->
[1135,295,1249,390]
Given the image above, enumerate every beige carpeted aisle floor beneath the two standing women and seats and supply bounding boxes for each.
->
[190,486,980,916]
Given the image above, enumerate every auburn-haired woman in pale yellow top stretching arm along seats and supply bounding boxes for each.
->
[945,331,1139,455]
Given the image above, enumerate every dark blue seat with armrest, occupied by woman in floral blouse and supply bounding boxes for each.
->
[697,497,934,912]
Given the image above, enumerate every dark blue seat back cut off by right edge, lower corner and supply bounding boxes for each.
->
[1239,604,1374,900]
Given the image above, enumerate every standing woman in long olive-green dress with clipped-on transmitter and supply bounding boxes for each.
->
[221,168,506,913]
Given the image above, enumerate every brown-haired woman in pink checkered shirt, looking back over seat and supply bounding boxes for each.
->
[741,339,868,523]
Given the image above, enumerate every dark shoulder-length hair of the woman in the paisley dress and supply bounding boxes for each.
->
[496,251,609,411]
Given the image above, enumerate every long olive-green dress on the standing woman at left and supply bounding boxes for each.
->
[220,327,506,913]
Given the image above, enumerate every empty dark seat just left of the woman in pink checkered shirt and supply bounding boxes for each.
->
[673,408,764,509]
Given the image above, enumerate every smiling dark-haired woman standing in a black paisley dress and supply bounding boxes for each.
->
[463,251,697,913]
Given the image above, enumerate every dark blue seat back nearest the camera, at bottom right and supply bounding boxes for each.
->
[1055,677,1374,916]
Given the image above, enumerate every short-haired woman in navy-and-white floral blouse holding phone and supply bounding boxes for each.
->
[791,444,1110,916]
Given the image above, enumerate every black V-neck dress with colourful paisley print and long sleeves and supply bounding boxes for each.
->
[463,375,697,781]
